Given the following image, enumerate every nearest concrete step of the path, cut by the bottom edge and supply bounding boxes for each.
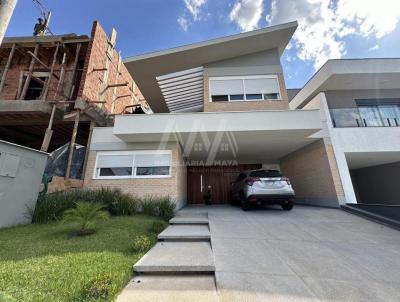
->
[116,275,219,302]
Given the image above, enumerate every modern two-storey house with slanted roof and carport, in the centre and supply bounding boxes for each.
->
[84,22,344,207]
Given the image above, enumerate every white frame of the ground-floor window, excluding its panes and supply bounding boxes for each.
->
[93,150,172,179]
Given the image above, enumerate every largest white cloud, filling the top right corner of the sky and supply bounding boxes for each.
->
[266,0,400,69]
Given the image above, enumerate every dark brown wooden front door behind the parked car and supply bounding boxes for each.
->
[187,164,261,204]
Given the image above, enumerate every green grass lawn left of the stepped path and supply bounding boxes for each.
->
[0,215,158,302]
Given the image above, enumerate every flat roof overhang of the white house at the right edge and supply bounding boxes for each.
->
[290,58,400,109]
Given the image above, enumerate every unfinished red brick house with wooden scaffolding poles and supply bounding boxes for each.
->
[0,21,147,155]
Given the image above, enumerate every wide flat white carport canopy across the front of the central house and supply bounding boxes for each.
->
[113,110,322,162]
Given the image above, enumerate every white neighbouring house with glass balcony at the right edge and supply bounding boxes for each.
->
[290,59,400,205]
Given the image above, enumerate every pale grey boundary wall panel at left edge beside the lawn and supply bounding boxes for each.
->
[0,140,48,228]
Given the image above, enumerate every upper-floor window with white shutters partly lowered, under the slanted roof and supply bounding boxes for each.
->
[210,75,281,102]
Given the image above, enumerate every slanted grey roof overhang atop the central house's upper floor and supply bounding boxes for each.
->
[124,21,297,113]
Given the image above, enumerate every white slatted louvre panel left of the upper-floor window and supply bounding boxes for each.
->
[156,67,204,112]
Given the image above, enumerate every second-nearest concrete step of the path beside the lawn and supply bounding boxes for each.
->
[133,242,215,274]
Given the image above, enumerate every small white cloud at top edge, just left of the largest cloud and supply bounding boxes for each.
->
[229,0,264,31]
